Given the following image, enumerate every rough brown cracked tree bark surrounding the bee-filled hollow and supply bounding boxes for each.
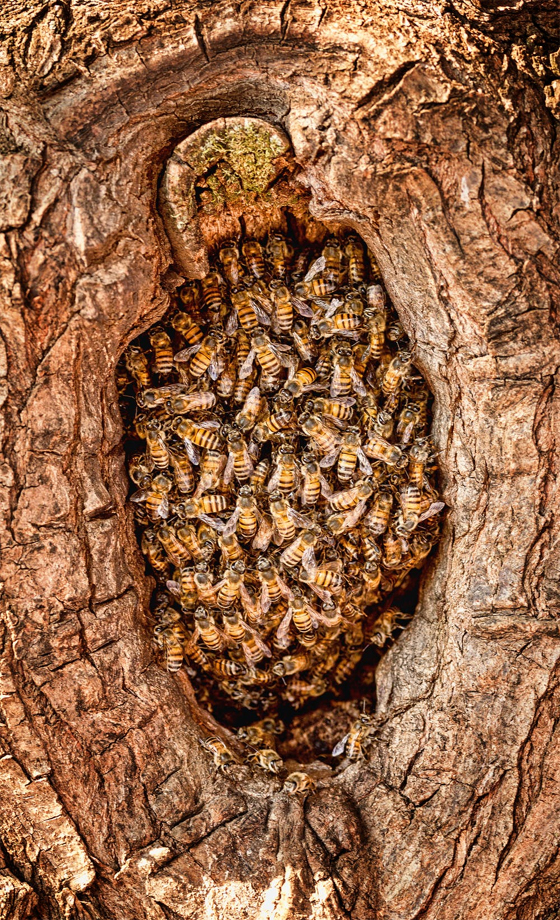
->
[0,0,560,920]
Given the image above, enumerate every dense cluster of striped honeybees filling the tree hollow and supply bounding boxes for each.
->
[118,233,443,724]
